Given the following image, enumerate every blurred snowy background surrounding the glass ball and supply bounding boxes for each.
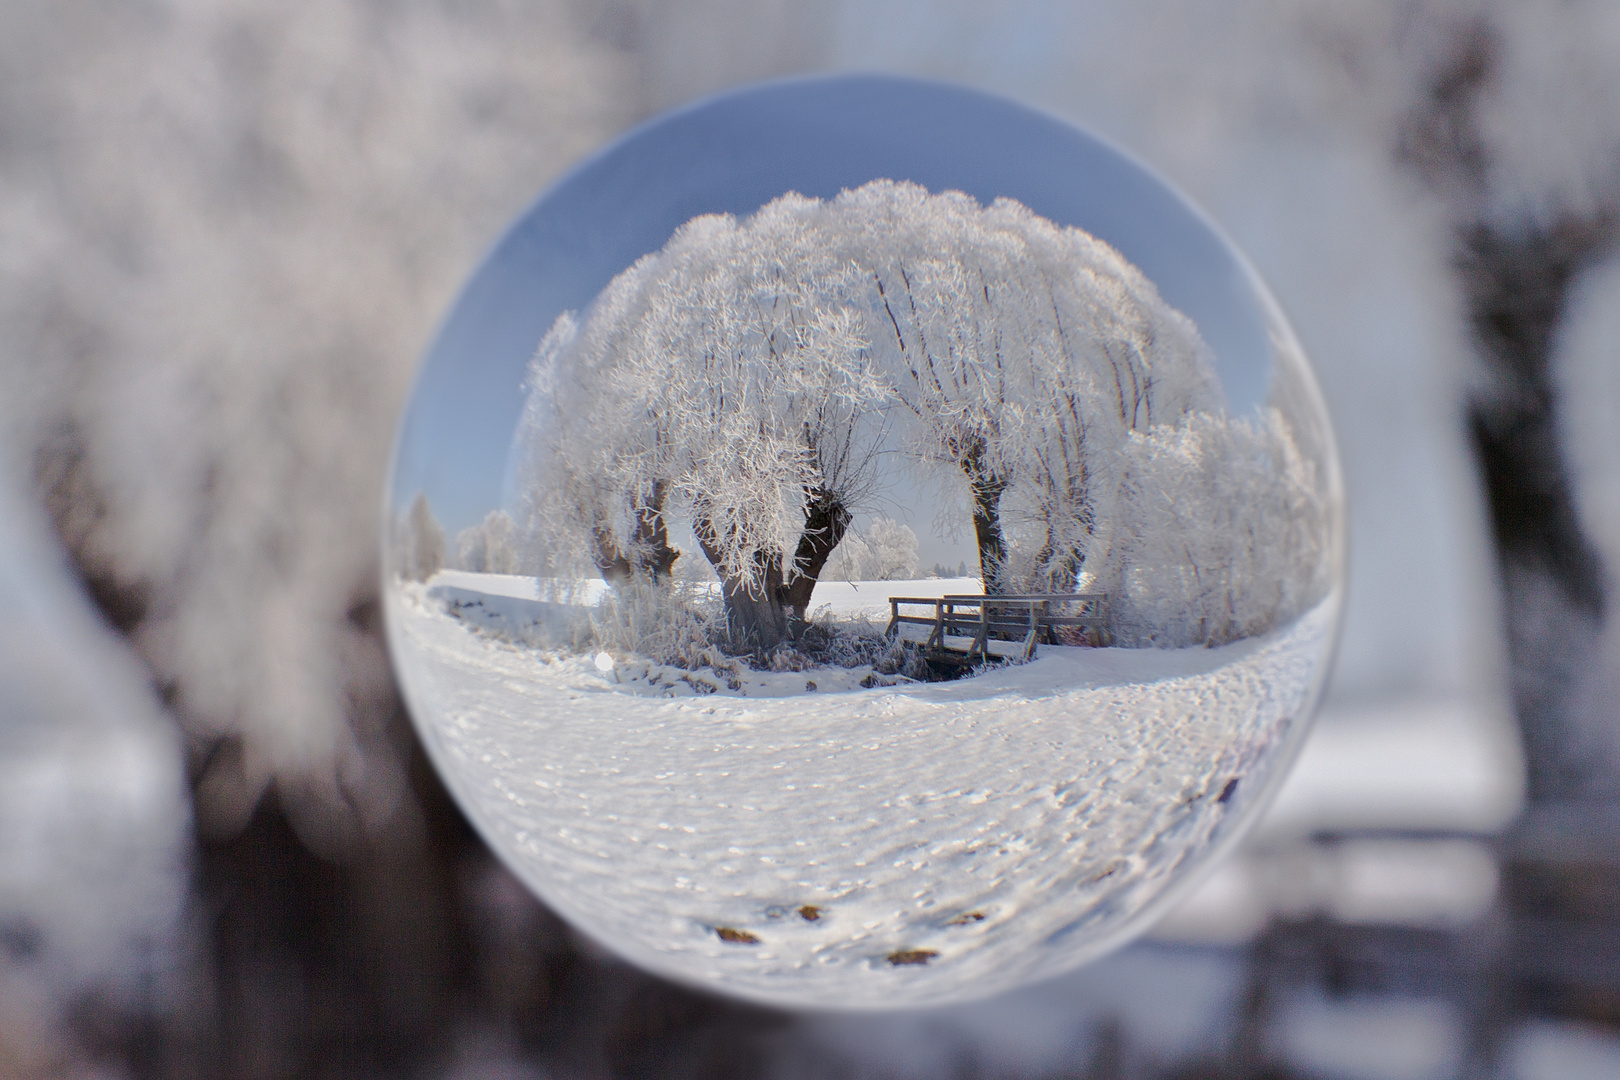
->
[0,0,1620,1080]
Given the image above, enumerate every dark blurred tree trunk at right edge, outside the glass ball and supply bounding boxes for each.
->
[1463,222,1620,803]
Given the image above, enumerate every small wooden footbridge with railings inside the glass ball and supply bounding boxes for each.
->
[885,593,1108,667]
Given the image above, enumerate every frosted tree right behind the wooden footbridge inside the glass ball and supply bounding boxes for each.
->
[826,181,1221,593]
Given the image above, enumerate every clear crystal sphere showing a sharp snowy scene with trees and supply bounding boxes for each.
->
[384,76,1343,1009]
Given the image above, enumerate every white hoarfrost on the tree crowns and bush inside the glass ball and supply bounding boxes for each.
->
[517,181,1330,646]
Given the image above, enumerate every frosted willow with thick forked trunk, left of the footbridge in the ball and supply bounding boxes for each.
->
[523,198,889,646]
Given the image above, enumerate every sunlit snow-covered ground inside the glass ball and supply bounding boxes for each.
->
[389,575,1337,1007]
